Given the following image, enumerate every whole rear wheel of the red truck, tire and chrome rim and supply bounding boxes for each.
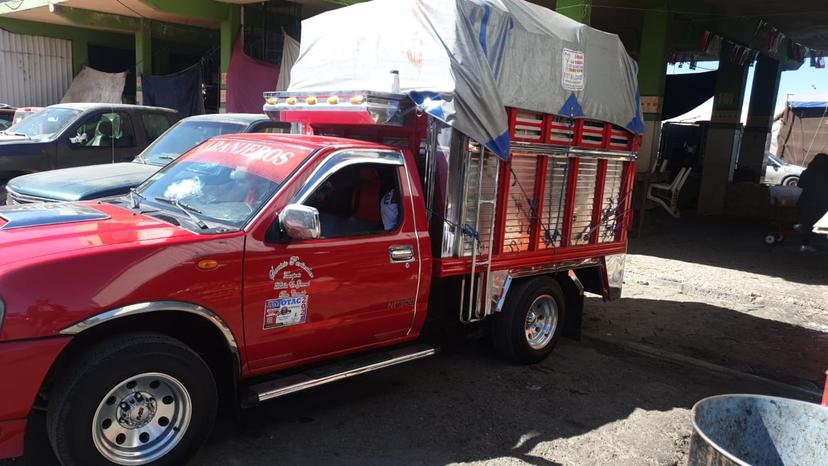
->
[492,277,566,364]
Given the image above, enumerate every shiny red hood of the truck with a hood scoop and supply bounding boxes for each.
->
[0,202,197,268]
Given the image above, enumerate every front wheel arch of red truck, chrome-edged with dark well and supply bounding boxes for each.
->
[37,301,242,412]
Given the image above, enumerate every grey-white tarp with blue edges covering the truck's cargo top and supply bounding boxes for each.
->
[288,0,644,158]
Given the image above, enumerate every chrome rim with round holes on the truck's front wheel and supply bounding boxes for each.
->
[92,372,193,465]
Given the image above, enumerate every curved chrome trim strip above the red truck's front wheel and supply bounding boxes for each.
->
[60,301,241,370]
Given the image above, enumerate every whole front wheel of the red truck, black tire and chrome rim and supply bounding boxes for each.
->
[46,333,217,466]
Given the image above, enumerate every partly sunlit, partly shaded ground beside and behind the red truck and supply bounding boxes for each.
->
[8,216,828,466]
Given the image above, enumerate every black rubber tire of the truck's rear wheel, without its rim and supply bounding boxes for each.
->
[492,277,566,364]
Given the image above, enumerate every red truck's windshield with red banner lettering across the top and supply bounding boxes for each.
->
[137,137,308,228]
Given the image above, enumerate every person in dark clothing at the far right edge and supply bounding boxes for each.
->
[797,154,828,251]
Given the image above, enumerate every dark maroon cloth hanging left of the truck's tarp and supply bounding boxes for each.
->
[227,39,279,113]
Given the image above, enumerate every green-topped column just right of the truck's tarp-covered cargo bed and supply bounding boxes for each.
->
[637,2,673,173]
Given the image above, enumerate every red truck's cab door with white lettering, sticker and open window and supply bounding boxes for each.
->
[239,151,421,370]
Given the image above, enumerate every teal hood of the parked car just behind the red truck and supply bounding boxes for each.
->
[8,162,161,201]
